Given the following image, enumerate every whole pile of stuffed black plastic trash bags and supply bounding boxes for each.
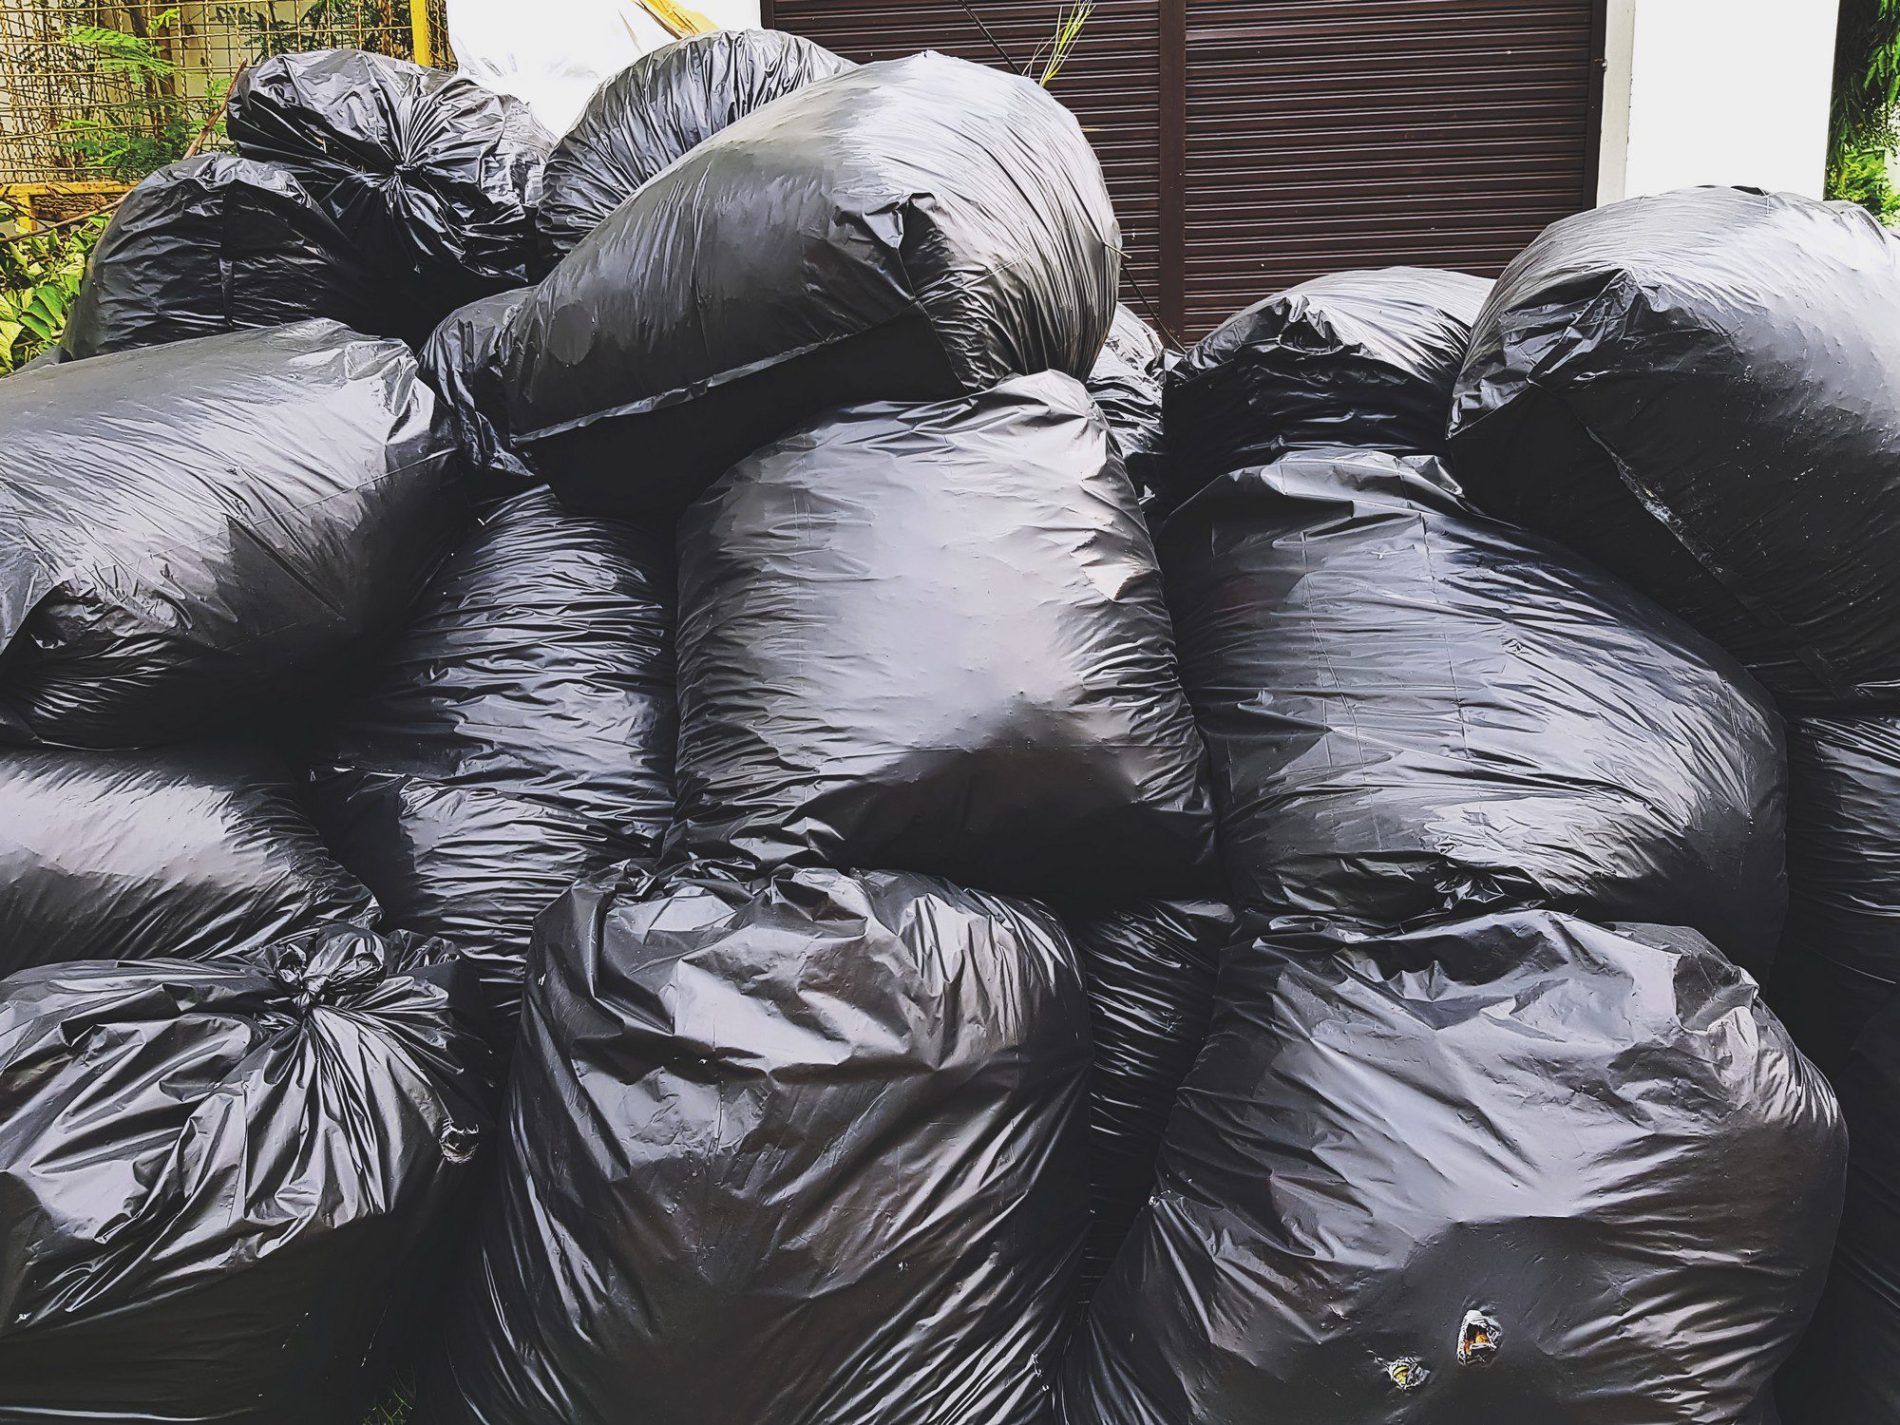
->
[0,30,1869,1425]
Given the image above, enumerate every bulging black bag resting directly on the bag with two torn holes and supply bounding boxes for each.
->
[1161,450,1788,975]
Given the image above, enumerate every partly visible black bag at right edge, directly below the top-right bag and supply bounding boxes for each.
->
[1769,718,1900,1079]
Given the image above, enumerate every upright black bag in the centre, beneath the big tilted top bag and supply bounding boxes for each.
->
[667,372,1214,904]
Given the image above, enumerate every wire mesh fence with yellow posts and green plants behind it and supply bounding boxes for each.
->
[0,0,454,203]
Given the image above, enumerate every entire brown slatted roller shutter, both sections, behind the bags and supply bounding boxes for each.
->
[766,0,1604,340]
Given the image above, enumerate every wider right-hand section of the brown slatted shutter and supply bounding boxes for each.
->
[1182,0,1602,336]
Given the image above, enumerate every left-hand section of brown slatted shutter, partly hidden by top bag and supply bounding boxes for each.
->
[766,0,1161,328]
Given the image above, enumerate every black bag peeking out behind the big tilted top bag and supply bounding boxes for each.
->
[536,30,857,264]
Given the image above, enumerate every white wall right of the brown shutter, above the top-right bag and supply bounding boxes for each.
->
[1598,0,1839,203]
